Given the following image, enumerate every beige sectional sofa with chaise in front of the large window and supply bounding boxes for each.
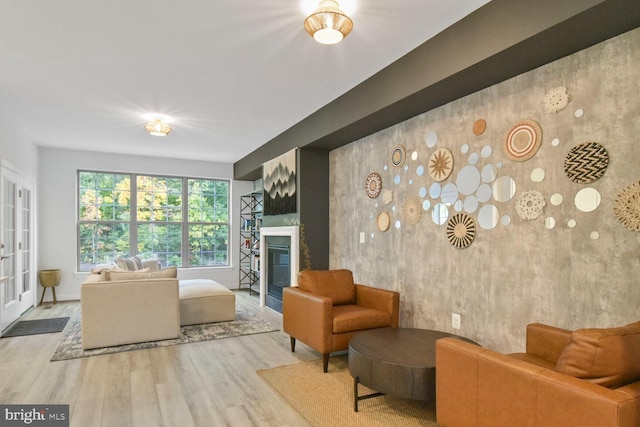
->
[80,264,236,349]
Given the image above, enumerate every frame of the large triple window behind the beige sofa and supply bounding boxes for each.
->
[76,169,232,272]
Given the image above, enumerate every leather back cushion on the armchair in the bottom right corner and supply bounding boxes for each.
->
[556,322,640,388]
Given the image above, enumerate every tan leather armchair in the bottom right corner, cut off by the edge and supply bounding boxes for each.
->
[436,322,640,427]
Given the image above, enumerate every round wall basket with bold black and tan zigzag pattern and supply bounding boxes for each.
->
[564,142,609,184]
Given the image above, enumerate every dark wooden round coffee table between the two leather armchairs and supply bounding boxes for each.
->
[349,328,477,412]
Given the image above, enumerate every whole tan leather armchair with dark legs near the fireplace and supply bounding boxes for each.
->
[282,270,400,372]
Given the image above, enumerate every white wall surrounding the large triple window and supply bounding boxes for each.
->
[38,147,253,300]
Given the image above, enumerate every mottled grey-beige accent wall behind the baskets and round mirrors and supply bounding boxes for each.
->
[329,28,640,352]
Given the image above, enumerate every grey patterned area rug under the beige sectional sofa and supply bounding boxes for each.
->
[51,307,278,362]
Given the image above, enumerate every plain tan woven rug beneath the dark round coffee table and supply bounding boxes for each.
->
[258,355,438,427]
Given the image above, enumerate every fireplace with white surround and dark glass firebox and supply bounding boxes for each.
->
[260,226,299,313]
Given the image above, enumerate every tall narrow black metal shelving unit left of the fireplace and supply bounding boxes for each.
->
[238,191,262,295]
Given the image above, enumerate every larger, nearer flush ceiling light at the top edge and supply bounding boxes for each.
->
[304,0,353,44]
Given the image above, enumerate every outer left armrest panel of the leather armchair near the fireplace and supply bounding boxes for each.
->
[282,287,333,353]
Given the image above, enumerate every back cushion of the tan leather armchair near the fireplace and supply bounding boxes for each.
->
[298,270,356,305]
